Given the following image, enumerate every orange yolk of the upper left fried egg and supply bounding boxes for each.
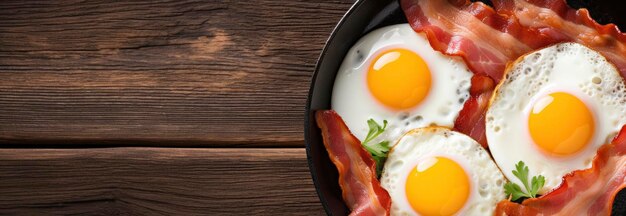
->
[367,49,431,110]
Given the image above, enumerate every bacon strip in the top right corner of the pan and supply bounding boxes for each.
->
[492,0,626,77]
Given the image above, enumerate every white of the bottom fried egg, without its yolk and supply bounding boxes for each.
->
[380,127,506,215]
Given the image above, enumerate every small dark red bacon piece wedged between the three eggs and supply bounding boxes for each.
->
[454,75,495,148]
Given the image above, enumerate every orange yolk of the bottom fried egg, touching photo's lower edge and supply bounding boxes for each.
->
[405,157,470,215]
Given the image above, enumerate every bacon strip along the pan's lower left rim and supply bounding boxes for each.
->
[315,110,391,215]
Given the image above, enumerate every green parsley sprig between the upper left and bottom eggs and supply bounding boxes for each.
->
[361,119,390,177]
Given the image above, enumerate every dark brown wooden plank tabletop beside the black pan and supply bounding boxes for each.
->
[0,0,353,215]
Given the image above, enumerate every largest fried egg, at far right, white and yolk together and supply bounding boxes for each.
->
[486,43,626,194]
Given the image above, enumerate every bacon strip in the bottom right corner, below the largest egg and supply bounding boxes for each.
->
[496,126,626,216]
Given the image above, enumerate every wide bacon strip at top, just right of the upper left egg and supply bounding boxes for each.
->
[400,0,554,82]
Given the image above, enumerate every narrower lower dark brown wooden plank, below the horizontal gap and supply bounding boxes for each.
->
[0,148,324,215]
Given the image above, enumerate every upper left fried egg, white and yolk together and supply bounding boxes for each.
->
[331,24,472,143]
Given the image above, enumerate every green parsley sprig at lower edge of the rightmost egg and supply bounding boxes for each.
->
[504,161,546,201]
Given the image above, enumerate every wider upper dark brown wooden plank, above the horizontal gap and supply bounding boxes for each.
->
[0,0,353,147]
